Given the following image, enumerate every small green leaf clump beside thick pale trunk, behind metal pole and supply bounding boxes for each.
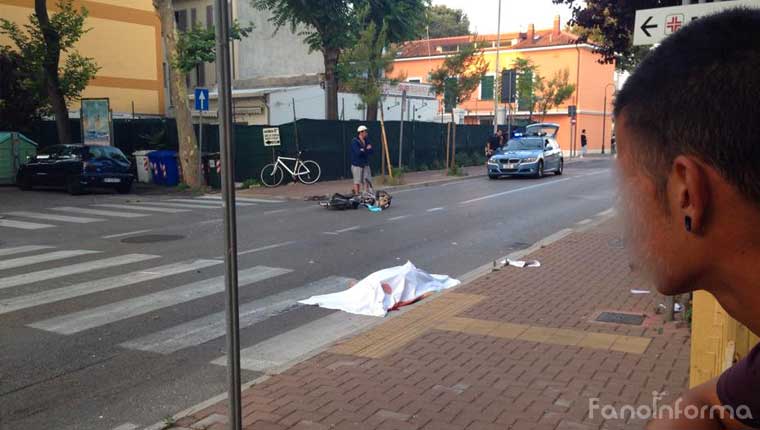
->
[173,20,253,73]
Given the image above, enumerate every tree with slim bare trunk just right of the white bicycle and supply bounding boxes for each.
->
[251,0,356,119]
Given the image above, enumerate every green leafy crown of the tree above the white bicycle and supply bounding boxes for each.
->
[251,0,356,51]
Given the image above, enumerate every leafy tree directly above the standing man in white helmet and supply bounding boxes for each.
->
[338,0,428,121]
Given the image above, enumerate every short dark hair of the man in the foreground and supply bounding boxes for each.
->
[614,8,760,202]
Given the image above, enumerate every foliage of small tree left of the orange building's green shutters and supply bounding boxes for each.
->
[430,43,488,112]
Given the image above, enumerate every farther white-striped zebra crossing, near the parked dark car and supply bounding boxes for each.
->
[0,195,282,232]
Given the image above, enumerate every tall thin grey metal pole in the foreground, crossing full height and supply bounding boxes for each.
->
[214,0,243,430]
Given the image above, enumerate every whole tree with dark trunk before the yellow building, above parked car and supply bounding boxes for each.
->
[0,0,99,144]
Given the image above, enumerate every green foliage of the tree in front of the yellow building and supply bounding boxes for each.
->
[0,0,99,107]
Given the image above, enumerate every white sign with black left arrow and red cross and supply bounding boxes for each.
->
[633,0,760,45]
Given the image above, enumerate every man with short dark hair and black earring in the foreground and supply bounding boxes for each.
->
[614,9,760,430]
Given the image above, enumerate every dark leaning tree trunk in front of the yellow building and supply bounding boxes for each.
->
[34,0,71,145]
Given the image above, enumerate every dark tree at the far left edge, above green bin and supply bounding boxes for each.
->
[0,46,47,132]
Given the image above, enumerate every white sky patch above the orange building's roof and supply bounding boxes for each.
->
[433,0,570,34]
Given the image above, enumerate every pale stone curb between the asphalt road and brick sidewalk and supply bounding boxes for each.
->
[143,205,616,430]
